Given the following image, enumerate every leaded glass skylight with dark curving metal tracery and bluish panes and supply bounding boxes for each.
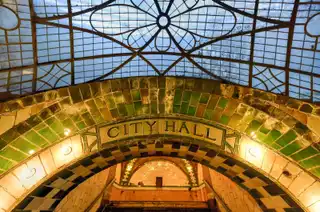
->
[0,0,320,102]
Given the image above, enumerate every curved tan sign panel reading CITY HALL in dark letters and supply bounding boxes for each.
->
[100,118,225,146]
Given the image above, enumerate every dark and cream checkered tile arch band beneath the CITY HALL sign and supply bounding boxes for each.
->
[13,137,304,211]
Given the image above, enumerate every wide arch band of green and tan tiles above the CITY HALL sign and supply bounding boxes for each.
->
[0,77,320,177]
